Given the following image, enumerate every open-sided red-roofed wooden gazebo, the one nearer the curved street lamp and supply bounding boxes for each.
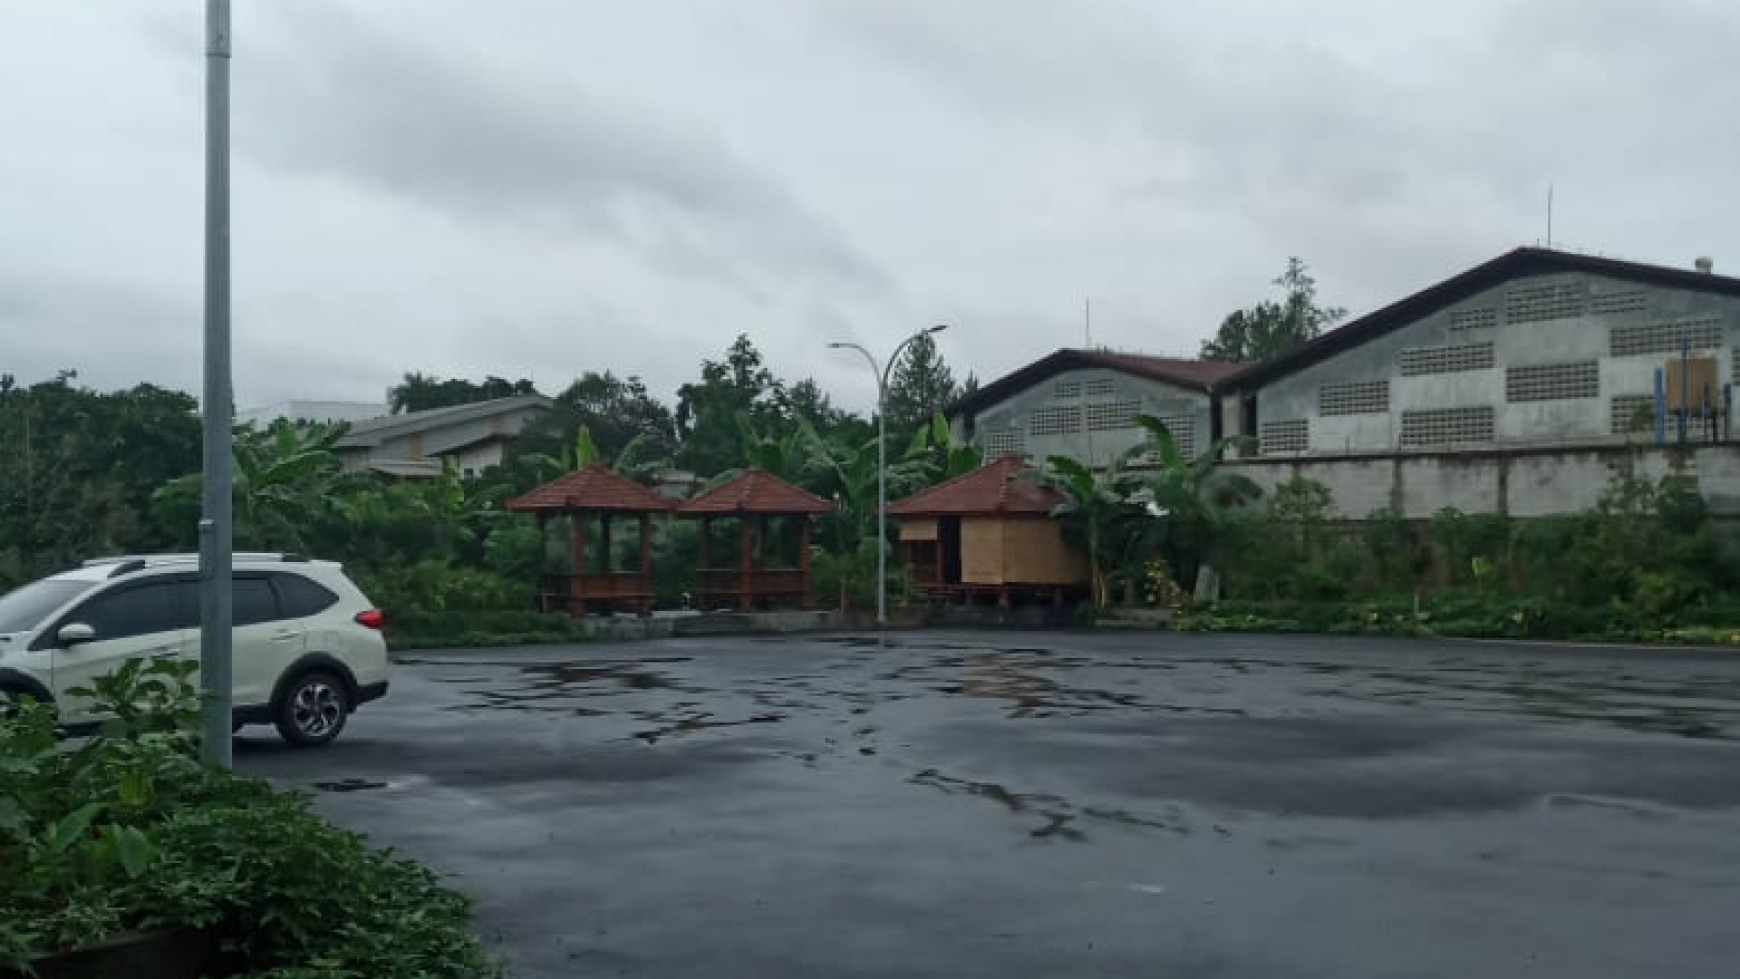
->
[677,470,833,612]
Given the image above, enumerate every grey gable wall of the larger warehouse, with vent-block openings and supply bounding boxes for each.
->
[1221,273,1740,454]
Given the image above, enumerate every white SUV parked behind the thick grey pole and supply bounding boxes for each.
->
[0,555,386,744]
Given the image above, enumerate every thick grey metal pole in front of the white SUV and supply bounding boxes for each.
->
[200,0,235,769]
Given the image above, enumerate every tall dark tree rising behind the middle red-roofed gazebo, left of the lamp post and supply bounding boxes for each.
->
[677,336,783,476]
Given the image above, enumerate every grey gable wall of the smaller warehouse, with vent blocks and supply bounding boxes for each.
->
[955,369,1213,466]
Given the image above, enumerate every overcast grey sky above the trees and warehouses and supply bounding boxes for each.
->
[0,0,1740,407]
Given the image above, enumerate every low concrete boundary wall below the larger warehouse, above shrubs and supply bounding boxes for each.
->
[1223,445,1740,520]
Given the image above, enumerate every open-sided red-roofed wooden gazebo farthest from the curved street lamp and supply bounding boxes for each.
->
[508,463,672,616]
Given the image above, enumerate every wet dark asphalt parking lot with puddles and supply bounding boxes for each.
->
[237,633,1740,979]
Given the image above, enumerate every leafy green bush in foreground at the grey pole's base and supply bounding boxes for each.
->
[0,661,499,979]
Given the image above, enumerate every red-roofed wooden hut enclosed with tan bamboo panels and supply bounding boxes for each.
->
[887,456,1088,605]
